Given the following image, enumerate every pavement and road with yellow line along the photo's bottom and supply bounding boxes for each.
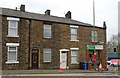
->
[2,69,120,78]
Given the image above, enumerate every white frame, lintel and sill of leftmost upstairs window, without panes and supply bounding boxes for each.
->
[7,17,20,37]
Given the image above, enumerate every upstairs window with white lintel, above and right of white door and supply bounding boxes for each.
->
[70,26,78,41]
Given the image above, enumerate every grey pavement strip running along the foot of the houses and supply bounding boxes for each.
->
[2,69,120,75]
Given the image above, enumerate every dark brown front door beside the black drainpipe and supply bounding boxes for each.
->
[32,49,38,69]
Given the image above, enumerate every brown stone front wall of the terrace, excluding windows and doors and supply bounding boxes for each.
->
[2,16,106,69]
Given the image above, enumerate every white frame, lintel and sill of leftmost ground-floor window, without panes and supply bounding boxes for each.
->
[6,43,19,64]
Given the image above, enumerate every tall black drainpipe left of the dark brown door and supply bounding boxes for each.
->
[28,20,31,69]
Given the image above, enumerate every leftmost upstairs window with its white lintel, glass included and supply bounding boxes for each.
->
[7,17,19,37]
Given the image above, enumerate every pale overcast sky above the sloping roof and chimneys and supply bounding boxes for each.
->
[0,0,120,40]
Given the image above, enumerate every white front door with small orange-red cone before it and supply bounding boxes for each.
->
[60,52,67,69]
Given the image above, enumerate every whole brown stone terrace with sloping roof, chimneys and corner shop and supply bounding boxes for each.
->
[0,5,106,70]
